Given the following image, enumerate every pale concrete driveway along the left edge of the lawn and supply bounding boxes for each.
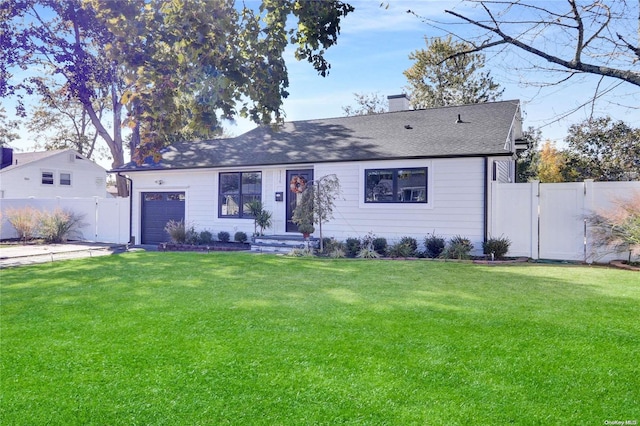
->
[0,241,127,269]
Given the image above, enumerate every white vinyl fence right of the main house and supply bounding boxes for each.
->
[489,181,640,263]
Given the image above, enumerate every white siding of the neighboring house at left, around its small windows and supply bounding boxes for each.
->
[0,151,107,198]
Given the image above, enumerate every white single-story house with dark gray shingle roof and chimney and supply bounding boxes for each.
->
[115,96,522,248]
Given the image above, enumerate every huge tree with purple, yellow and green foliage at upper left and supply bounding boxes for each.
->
[0,0,353,194]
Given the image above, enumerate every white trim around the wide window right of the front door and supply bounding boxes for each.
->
[358,160,434,211]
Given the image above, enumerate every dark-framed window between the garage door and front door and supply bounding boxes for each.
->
[218,172,262,218]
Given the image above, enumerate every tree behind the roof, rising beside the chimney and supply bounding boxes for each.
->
[404,37,504,109]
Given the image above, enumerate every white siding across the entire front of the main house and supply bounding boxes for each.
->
[131,158,485,248]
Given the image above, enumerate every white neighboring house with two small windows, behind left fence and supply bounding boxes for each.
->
[0,147,107,198]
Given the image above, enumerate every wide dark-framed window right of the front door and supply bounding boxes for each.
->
[365,167,427,203]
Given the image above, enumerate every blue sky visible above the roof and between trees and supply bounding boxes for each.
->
[8,0,640,164]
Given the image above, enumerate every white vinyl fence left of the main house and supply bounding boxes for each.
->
[0,197,129,244]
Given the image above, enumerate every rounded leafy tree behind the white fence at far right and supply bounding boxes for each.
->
[565,117,640,181]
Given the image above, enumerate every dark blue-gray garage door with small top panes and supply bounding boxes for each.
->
[141,192,185,244]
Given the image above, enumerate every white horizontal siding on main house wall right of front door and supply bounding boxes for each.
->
[315,158,484,248]
